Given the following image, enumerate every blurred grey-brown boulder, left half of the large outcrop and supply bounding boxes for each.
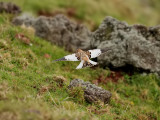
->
[13,15,91,51]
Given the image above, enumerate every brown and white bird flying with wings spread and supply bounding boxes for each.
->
[53,49,111,69]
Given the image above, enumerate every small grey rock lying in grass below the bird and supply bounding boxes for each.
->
[68,79,112,104]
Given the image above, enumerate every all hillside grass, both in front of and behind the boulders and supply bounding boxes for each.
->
[0,0,160,120]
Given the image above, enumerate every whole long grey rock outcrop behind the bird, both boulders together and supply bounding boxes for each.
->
[13,15,160,75]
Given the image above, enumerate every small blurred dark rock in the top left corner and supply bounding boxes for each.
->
[0,2,21,14]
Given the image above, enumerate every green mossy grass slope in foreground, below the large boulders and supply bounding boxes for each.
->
[0,0,160,120]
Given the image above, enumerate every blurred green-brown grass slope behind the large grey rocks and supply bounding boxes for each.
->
[0,0,160,30]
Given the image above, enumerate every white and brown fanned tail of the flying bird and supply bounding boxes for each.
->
[76,60,97,69]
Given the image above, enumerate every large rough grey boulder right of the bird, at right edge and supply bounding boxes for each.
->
[91,17,160,74]
